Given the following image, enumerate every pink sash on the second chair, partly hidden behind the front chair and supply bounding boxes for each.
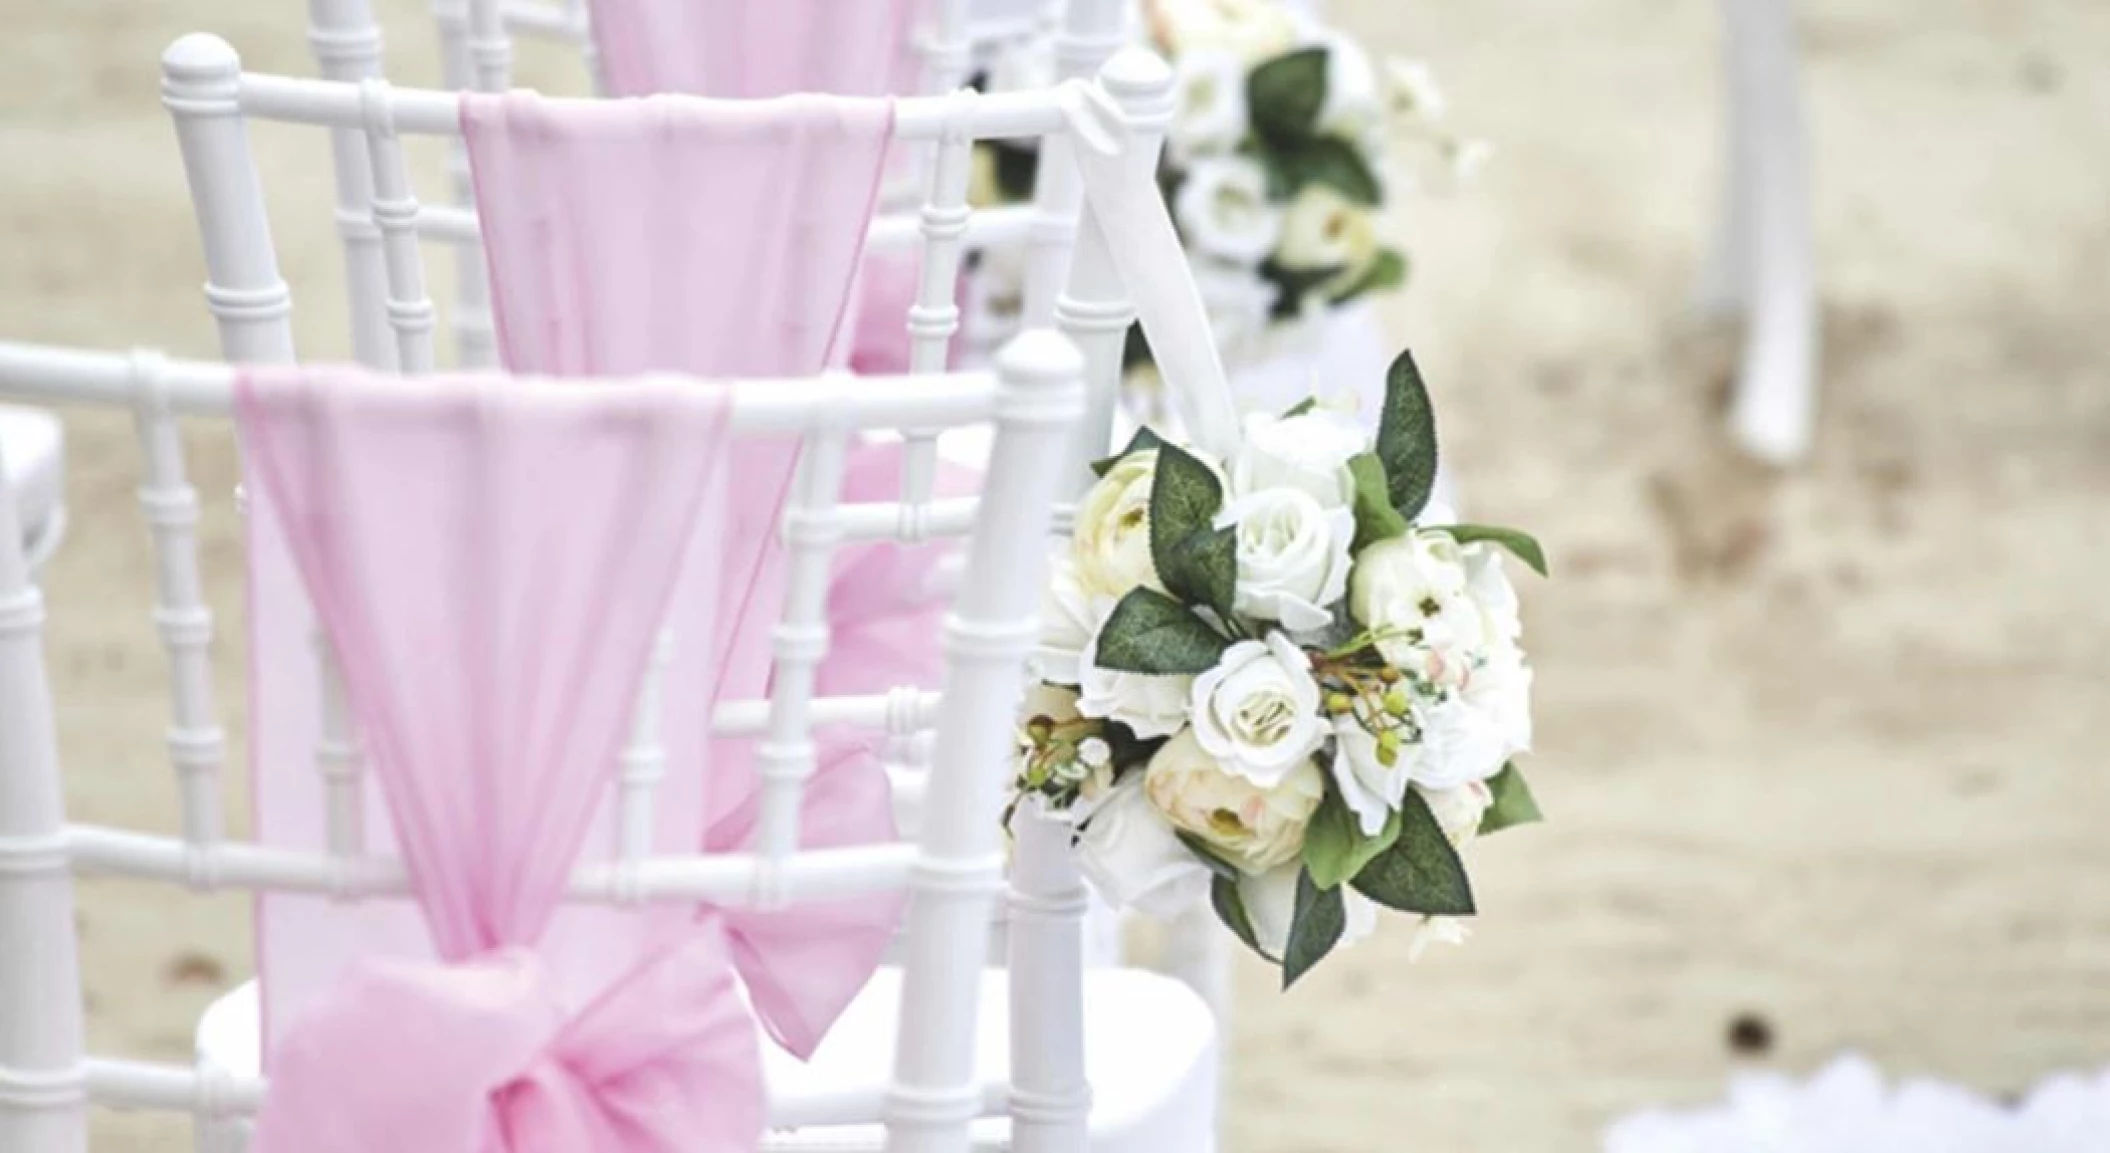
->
[462,95,960,1056]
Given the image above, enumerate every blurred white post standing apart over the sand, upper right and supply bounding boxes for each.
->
[1701,0,1817,465]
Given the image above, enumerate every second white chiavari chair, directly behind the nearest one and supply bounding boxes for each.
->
[148,36,1236,1140]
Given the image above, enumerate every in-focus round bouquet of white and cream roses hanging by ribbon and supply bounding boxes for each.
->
[1015,353,1545,986]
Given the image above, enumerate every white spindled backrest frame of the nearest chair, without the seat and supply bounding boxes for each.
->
[0,332,1085,1153]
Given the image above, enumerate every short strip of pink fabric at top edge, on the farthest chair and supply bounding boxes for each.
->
[591,0,912,99]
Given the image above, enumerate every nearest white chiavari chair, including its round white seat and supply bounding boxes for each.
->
[0,320,1215,1153]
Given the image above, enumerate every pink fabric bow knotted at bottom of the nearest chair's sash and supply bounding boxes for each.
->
[255,923,766,1153]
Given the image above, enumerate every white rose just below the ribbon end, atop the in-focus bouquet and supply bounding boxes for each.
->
[1215,488,1355,631]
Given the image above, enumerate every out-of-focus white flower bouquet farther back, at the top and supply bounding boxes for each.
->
[966,0,1485,370]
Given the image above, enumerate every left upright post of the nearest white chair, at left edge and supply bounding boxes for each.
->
[0,407,89,1153]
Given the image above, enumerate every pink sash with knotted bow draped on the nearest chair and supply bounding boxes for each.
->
[236,370,764,1153]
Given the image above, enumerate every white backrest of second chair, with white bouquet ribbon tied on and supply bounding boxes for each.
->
[162,27,1236,485]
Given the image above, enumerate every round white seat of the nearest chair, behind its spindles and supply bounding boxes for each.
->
[196,967,1217,1153]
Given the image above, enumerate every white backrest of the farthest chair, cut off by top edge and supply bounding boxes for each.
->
[308,0,1127,380]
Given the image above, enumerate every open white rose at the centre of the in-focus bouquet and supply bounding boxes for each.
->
[1192,634,1327,788]
